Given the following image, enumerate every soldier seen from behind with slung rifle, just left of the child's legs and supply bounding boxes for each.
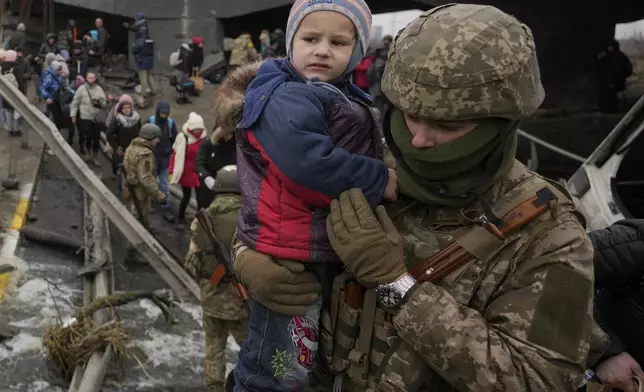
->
[185,165,248,392]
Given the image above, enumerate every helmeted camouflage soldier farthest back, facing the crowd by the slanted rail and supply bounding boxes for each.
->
[123,124,167,251]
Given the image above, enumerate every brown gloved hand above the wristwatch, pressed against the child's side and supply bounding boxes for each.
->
[326,189,407,288]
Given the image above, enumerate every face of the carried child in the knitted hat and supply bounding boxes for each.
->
[292,11,356,82]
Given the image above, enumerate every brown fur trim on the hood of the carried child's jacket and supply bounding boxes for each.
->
[211,61,263,144]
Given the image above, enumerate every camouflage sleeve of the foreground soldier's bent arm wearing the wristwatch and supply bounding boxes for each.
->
[394,213,593,392]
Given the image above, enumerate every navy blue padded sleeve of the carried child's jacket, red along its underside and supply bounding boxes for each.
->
[247,88,389,207]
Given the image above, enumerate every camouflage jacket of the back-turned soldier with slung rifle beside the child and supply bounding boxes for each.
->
[185,194,248,320]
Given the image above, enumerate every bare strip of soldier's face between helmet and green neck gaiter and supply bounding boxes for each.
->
[405,113,477,148]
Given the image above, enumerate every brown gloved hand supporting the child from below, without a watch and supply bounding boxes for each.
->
[235,249,322,316]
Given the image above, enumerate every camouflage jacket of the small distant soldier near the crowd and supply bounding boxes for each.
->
[123,137,165,200]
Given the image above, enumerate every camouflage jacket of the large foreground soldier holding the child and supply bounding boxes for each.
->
[311,162,606,392]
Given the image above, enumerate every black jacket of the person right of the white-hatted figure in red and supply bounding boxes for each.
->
[195,130,237,183]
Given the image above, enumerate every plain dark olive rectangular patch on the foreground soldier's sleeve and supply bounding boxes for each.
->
[528,264,593,359]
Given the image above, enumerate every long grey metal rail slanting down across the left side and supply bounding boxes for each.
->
[0,77,200,299]
